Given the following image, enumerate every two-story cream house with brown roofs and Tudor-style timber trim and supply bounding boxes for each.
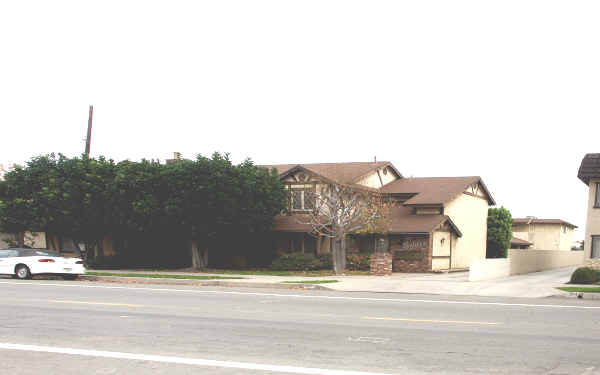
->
[263,161,495,272]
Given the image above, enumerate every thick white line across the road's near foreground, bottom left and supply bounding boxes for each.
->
[0,343,389,375]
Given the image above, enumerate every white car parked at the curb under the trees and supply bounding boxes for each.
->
[0,248,85,279]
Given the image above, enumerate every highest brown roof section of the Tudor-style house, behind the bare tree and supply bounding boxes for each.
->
[260,161,402,184]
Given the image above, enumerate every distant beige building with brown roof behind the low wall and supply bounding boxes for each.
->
[512,217,577,251]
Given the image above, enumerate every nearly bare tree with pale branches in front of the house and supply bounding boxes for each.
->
[300,183,390,275]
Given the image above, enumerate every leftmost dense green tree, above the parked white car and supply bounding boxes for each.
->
[0,154,116,260]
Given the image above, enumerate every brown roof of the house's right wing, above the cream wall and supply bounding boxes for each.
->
[380,176,496,205]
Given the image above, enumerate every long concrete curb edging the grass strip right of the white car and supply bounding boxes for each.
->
[79,275,333,291]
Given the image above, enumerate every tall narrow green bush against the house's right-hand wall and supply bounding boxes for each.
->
[486,207,512,258]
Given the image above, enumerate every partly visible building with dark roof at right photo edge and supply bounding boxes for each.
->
[577,153,600,269]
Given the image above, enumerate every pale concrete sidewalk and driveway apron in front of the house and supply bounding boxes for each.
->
[86,267,576,298]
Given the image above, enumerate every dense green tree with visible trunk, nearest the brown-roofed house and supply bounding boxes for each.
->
[164,153,287,268]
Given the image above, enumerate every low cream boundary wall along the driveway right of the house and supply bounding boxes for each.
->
[469,249,583,281]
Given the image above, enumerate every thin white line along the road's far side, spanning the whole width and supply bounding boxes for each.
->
[0,281,600,310]
